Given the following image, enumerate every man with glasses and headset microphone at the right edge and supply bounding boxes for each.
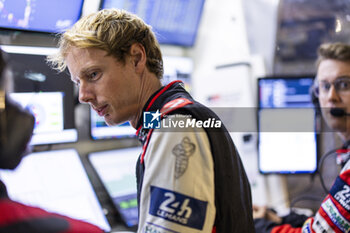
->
[253,43,350,233]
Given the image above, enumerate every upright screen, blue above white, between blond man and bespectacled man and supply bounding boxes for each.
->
[258,75,317,174]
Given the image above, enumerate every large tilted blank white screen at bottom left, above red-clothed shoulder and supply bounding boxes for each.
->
[0,149,111,232]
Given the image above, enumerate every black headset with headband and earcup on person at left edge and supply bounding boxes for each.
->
[0,50,34,169]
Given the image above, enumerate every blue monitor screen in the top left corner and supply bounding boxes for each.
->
[0,0,83,33]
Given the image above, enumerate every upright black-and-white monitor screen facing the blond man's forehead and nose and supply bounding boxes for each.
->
[1,46,78,145]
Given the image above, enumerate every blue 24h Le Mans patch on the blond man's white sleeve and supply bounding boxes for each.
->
[149,186,208,230]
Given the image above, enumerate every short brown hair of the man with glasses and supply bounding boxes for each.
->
[316,42,350,67]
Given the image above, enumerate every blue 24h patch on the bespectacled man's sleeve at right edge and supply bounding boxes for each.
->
[330,177,350,211]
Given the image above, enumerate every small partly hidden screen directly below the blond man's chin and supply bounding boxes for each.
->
[90,108,136,140]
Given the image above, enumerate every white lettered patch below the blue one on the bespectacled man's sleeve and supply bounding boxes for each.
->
[321,198,350,232]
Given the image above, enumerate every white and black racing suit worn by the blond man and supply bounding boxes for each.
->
[137,81,254,233]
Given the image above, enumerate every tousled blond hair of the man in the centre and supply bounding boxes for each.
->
[47,9,163,78]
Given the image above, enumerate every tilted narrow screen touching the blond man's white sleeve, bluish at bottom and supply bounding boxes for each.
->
[89,147,141,227]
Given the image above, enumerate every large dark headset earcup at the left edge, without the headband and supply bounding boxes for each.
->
[0,101,35,169]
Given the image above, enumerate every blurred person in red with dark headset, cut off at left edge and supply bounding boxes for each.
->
[0,50,103,233]
